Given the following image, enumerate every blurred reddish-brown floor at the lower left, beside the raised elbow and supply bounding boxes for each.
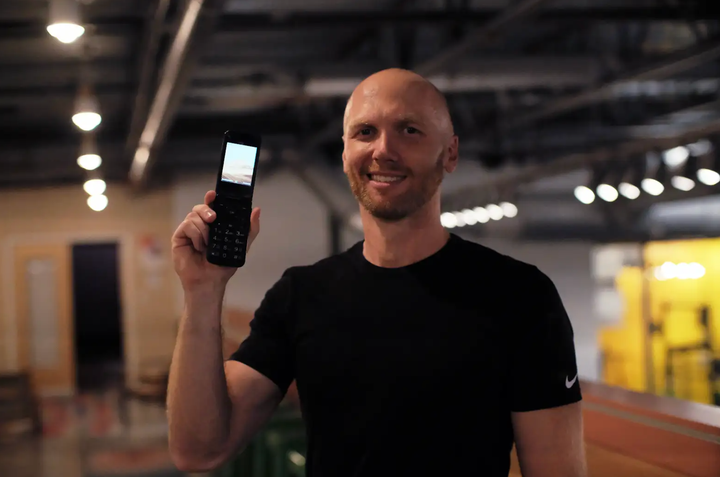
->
[0,392,185,477]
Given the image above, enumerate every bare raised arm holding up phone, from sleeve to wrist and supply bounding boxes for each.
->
[168,292,282,472]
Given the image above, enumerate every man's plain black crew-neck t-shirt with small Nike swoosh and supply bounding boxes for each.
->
[231,234,581,477]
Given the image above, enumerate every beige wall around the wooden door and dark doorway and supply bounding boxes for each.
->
[0,184,176,383]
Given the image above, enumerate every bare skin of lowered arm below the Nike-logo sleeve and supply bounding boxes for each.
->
[512,402,587,477]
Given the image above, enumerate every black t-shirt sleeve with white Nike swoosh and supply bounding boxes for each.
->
[510,267,582,412]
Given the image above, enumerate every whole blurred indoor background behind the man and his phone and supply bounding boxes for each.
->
[0,0,720,477]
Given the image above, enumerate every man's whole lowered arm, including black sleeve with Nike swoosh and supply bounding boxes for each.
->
[510,268,587,477]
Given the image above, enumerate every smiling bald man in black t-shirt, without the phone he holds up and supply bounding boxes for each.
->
[168,69,586,477]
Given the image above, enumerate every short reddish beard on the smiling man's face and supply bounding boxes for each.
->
[347,154,444,222]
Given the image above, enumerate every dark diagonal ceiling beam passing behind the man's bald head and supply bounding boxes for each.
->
[304,0,548,151]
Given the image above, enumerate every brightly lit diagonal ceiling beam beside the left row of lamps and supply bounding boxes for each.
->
[130,0,224,187]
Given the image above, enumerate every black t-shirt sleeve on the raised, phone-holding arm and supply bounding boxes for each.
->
[229,270,295,395]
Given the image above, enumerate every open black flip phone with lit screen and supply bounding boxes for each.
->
[207,131,261,268]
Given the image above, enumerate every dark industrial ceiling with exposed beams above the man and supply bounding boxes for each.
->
[0,0,720,238]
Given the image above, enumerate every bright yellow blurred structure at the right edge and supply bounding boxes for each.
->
[598,239,720,404]
